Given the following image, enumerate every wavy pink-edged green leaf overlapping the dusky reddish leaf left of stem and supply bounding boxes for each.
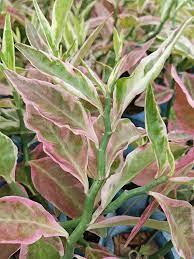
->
[25,105,88,192]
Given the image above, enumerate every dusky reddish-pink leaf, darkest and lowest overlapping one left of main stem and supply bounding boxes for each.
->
[30,157,85,218]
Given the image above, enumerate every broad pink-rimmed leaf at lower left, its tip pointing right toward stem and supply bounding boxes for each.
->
[0,196,68,244]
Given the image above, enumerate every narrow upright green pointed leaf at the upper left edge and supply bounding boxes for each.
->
[1,14,15,70]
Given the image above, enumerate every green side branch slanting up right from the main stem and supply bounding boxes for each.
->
[104,176,168,213]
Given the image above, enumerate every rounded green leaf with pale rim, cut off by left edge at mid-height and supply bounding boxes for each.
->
[0,132,18,183]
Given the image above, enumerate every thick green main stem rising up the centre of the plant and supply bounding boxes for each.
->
[63,92,111,259]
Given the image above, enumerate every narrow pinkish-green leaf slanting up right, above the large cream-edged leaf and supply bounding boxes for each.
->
[71,19,107,67]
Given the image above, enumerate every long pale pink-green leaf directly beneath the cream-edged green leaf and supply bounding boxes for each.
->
[5,70,98,143]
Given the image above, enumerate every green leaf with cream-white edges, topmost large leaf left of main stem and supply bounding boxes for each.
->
[16,44,102,111]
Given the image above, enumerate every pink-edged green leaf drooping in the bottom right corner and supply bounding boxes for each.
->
[149,192,194,259]
